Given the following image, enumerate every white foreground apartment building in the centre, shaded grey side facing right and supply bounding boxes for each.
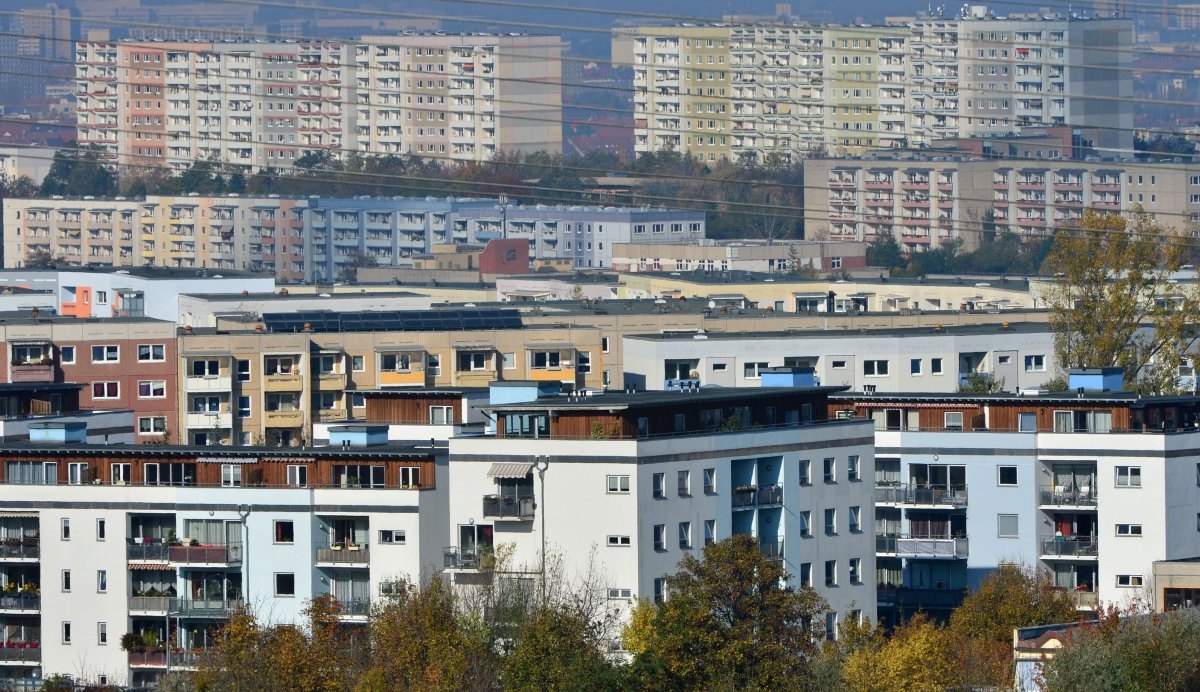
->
[444,371,874,638]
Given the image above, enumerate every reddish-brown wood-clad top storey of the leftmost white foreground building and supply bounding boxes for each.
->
[0,449,437,491]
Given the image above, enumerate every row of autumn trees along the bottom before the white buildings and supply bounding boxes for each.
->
[119,536,1200,692]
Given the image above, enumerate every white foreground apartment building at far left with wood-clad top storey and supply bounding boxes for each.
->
[0,436,448,687]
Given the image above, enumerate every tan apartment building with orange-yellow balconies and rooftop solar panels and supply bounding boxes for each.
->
[179,308,604,446]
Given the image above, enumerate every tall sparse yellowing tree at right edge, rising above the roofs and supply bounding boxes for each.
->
[1043,211,1200,393]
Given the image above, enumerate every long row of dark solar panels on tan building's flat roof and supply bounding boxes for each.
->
[263,308,524,332]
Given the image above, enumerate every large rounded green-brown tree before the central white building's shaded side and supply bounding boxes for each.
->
[634,535,826,690]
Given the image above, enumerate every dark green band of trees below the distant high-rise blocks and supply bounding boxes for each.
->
[25,150,804,240]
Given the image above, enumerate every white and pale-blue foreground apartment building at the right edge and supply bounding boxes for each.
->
[830,368,1200,621]
